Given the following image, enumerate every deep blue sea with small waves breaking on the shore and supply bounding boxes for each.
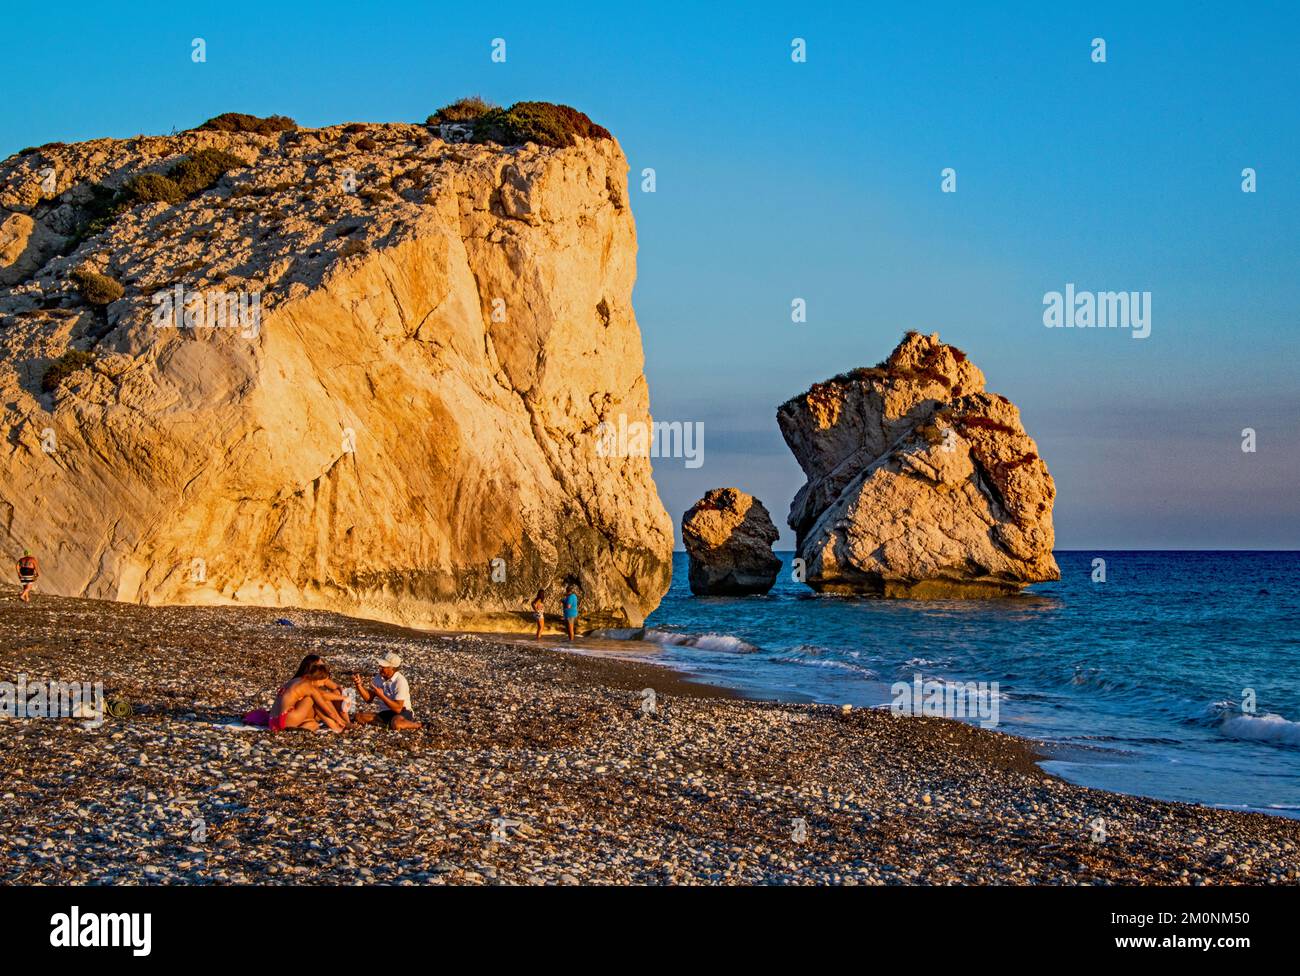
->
[595,551,1300,816]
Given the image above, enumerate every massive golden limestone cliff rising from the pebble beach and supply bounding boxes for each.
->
[0,118,672,628]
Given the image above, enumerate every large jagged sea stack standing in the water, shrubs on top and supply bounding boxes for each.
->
[776,333,1061,599]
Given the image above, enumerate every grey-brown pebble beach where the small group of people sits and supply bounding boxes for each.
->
[0,593,1300,885]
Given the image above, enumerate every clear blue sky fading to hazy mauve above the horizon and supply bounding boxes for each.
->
[0,0,1300,548]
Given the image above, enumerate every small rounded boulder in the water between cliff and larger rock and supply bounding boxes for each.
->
[681,489,781,597]
